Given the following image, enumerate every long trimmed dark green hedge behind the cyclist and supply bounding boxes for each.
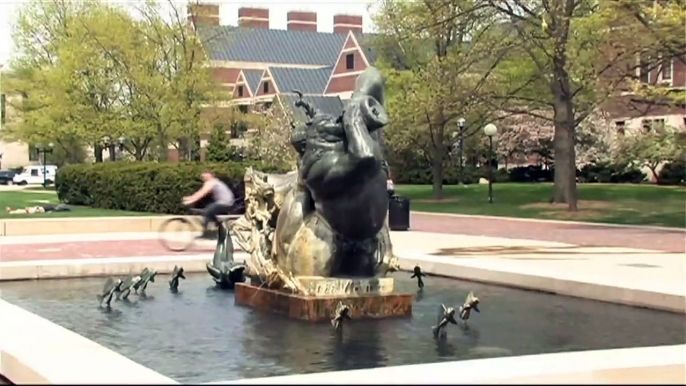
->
[55,162,287,214]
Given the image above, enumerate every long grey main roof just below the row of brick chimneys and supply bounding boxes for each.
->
[196,25,347,66]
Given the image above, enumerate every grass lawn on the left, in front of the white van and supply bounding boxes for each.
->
[0,190,151,219]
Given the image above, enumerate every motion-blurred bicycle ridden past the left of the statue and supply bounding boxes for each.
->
[158,198,245,252]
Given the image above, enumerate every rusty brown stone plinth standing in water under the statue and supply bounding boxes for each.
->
[235,283,413,322]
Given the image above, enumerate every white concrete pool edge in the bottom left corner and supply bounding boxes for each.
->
[0,299,178,384]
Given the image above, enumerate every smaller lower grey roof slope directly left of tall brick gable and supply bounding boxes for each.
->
[269,67,333,94]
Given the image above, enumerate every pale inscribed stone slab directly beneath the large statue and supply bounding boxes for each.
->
[297,276,393,297]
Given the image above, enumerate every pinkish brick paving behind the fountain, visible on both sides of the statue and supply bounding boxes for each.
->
[0,213,686,262]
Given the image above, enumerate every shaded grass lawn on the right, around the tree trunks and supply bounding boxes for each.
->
[396,183,686,228]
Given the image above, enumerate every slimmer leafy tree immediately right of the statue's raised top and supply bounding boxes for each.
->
[373,0,507,199]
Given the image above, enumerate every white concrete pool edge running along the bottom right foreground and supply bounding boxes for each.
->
[207,345,686,385]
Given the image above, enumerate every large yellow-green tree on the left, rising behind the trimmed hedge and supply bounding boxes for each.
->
[9,0,223,161]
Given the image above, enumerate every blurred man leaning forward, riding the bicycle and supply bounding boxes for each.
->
[183,172,236,237]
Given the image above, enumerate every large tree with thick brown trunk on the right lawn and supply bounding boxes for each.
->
[483,0,686,211]
